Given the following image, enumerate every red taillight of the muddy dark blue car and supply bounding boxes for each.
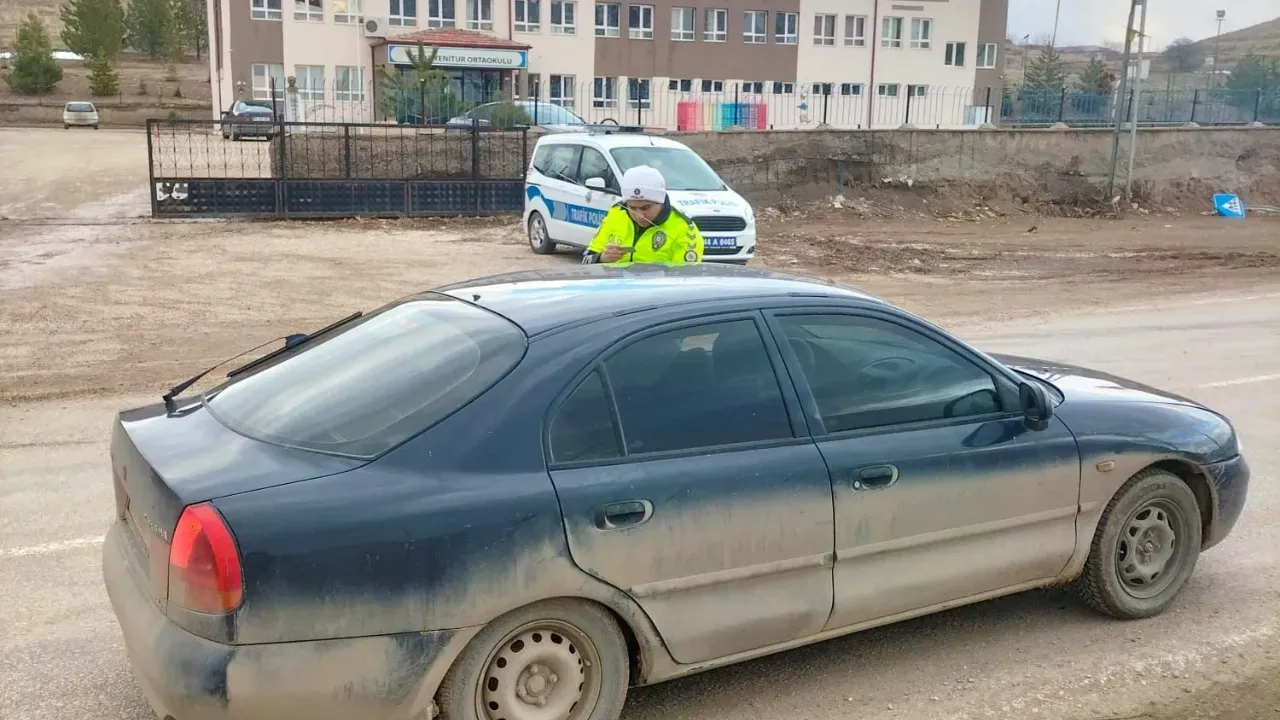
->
[169,502,244,614]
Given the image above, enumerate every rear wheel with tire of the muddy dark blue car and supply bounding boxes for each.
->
[436,600,630,720]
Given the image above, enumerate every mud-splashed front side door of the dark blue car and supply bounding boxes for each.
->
[769,309,1080,629]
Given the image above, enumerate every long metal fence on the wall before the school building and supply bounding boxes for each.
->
[257,76,1280,132]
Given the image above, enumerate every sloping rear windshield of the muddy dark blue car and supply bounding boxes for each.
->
[205,296,527,457]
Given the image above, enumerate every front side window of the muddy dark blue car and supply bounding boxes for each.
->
[778,315,1001,433]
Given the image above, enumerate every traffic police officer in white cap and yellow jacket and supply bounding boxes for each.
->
[582,165,703,265]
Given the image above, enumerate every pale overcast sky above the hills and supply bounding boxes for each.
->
[1009,0,1280,47]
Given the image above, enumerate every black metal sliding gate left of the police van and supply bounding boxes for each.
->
[147,115,530,218]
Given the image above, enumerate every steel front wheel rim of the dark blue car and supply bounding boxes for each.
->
[1116,498,1188,600]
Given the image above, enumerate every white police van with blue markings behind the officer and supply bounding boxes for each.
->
[525,126,755,264]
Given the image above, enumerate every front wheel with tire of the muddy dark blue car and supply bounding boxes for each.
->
[1075,468,1202,620]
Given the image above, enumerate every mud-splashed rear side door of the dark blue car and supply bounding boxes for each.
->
[548,313,833,662]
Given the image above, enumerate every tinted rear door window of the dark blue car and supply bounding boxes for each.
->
[605,320,791,455]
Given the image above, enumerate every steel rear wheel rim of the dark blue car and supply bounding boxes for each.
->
[476,620,600,720]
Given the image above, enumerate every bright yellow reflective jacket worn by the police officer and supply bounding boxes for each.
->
[584,202,703,265]
